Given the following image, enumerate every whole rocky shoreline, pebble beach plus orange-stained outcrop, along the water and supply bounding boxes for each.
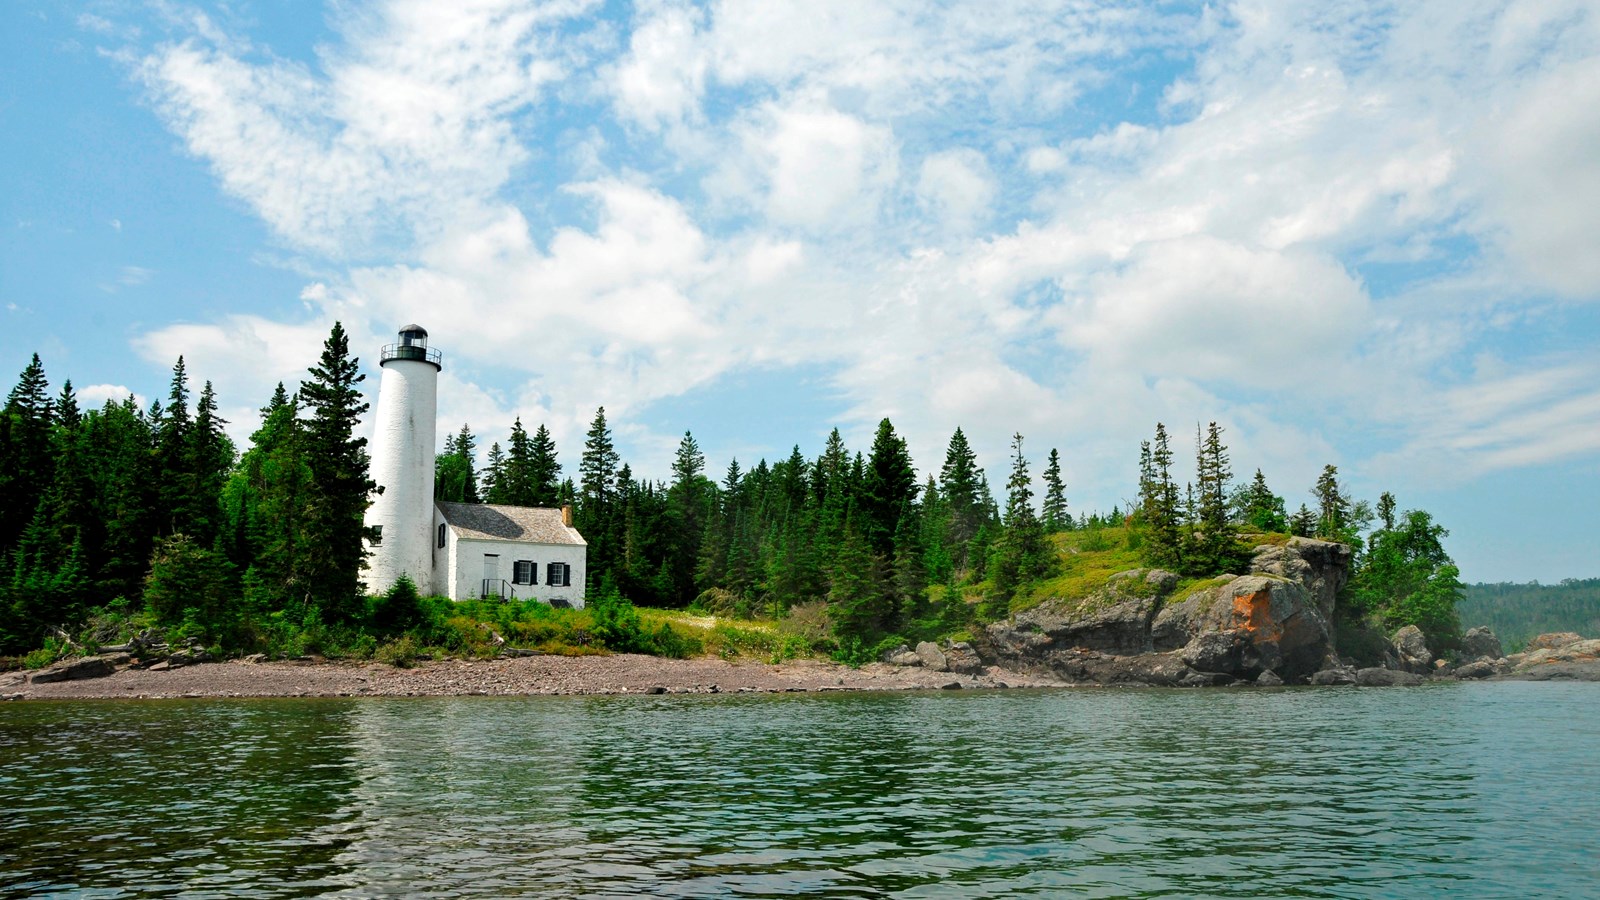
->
[0,538,1600,700]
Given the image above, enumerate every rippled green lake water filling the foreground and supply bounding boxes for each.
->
[0,684,1600,897]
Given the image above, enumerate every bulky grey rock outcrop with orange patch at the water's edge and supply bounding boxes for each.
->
[978,538,1350,684]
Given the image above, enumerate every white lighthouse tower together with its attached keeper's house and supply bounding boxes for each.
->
[365,325,589,607]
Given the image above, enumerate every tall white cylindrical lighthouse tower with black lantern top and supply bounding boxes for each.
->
[366,325,442,594]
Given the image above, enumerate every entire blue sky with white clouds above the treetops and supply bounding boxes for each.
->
[0,0,1600,583]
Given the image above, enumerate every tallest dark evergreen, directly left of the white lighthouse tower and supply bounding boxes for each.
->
[299,322,378,621]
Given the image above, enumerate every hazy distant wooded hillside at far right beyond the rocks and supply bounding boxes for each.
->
[1456,578,1600,652]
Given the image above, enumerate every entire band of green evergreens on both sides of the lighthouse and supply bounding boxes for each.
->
[0,325,1459,652]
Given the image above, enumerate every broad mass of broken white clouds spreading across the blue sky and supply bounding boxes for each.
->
[118,0,1600,504]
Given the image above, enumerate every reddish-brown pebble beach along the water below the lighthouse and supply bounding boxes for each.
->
[0,653,1061,700]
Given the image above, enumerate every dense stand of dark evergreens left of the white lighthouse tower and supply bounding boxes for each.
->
[0,323,373,652]
